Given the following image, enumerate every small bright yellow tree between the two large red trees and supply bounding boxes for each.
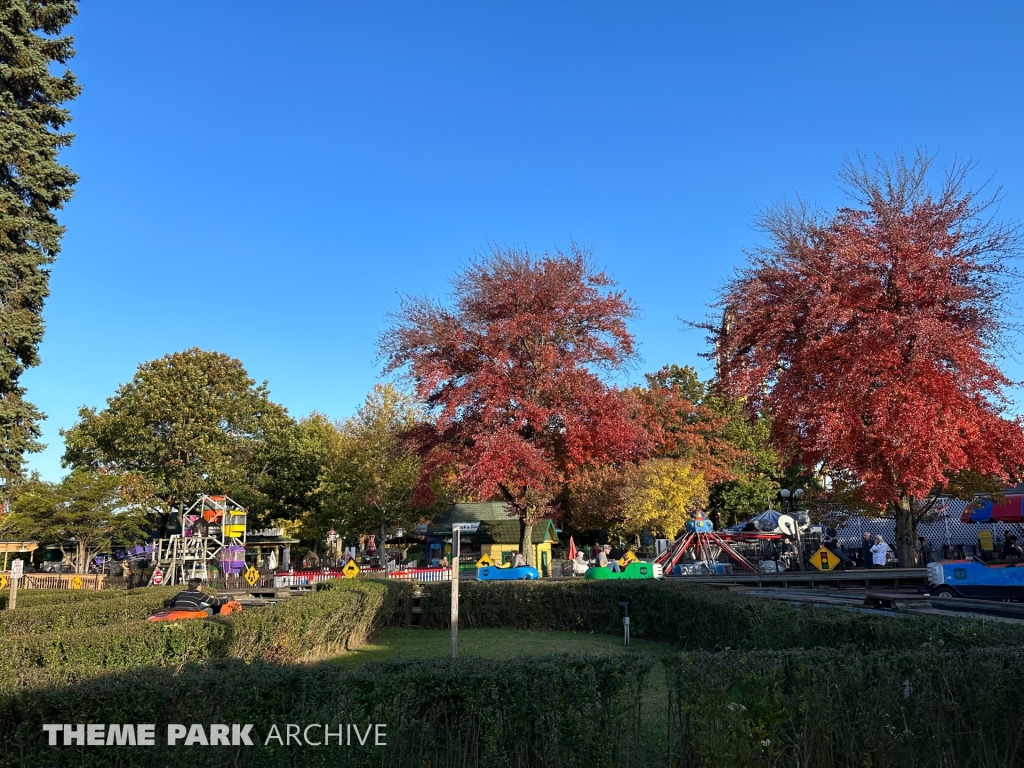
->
[621,459,708,539]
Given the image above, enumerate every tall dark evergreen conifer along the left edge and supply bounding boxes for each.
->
[0,0,80,486]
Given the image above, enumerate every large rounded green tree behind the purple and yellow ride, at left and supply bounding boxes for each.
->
[61,348,294,536]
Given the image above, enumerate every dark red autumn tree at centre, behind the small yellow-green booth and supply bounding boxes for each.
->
[380,246,646,560]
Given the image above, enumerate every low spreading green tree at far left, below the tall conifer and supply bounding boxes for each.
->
[6,470,151,573]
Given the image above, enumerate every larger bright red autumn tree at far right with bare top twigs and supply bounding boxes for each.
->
[705,154,1024,563]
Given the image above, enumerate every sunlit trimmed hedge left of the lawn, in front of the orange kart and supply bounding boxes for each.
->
[0,582,411,689]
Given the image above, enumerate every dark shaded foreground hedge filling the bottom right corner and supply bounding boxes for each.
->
[666,648,1024,768]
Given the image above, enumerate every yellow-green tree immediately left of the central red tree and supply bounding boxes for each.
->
[329,384,443,561]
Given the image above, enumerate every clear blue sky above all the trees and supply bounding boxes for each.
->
[24,0,1024,479]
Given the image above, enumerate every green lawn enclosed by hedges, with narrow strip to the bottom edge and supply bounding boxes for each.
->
[332,629,678,764]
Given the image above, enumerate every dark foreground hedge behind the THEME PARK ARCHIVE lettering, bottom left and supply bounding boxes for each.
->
[0,654,652,768]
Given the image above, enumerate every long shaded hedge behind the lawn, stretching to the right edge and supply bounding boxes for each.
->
[421,580,1024,650]
